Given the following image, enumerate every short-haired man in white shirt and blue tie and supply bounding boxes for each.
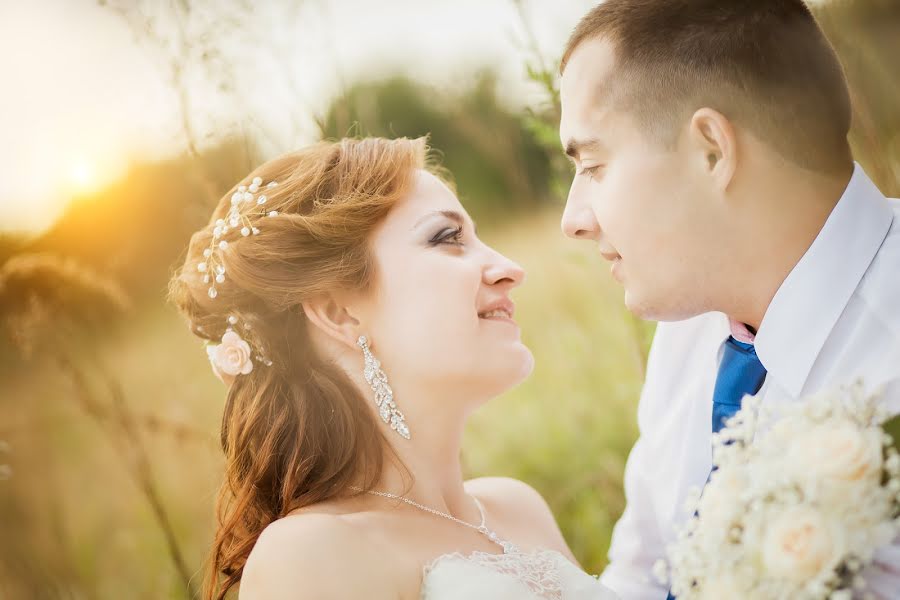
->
[560,0,900,600]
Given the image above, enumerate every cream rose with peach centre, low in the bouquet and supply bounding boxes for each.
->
[762,506,842,582]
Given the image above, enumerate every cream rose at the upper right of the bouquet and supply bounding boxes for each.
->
[788,420,883,482]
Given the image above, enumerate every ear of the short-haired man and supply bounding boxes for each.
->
[688,108,737,191]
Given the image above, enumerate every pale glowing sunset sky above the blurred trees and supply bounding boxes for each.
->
[0,0,593,238]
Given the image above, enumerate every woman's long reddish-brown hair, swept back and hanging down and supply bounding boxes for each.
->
[169,138,428,600]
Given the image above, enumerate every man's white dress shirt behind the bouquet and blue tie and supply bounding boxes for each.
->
[601,164,900,600]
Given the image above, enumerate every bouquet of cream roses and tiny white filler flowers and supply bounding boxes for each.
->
[657,382,900,600]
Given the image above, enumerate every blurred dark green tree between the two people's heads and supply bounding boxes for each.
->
[323,71,558,224]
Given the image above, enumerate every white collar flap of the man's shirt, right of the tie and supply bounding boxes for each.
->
[755,163,894,397]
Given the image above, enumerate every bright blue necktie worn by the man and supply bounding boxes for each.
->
[666,336,766,600]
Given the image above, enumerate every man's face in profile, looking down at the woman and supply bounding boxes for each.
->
[560,40,714,320]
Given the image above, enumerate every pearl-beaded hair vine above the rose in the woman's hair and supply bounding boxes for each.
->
[197,177,278,299]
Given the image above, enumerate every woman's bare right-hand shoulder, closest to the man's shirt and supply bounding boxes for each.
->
[466,477,578,564]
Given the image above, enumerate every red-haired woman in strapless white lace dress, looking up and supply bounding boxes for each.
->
[170,139,612,600]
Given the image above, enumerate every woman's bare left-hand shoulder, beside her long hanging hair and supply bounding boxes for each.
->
[240,512,395,600]
